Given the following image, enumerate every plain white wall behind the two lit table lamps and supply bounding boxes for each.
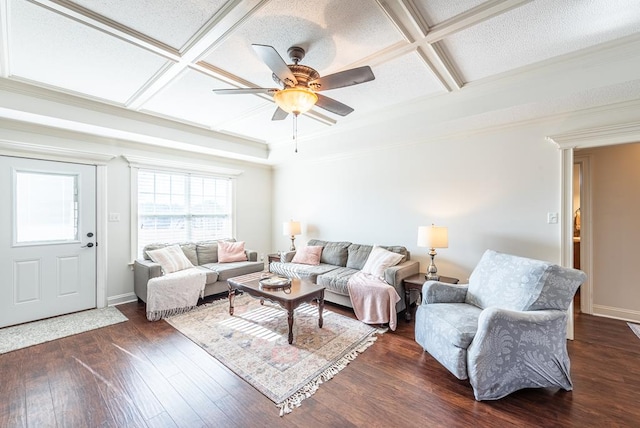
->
[273,106,638,288]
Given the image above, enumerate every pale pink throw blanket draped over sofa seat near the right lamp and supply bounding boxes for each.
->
[347,272,400,330]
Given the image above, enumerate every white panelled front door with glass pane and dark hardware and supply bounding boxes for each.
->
[0,156,96,327]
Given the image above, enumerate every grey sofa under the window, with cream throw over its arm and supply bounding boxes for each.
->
[133,239,264,303]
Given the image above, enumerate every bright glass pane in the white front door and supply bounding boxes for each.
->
[14,171,78,243]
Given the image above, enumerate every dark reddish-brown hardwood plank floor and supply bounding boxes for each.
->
[0,303,640,428]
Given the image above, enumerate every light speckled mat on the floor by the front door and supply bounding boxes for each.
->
[0,307,128,354]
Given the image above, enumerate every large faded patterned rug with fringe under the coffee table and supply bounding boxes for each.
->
[165,295,377,416]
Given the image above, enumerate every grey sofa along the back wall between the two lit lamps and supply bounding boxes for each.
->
[269,239,420,312]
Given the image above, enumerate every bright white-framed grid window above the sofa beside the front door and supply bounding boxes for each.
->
[137,169,233,256]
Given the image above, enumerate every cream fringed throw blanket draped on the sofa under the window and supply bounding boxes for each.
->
[147,268,207,321]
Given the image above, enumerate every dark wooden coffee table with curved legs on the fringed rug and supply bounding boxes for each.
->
[227,272,324,344]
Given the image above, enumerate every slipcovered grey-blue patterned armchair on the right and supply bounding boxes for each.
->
[415,250,586,401]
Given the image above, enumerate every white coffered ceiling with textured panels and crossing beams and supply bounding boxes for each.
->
[0,0,640,161]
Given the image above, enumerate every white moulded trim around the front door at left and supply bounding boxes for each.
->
[0,140,116,308]
